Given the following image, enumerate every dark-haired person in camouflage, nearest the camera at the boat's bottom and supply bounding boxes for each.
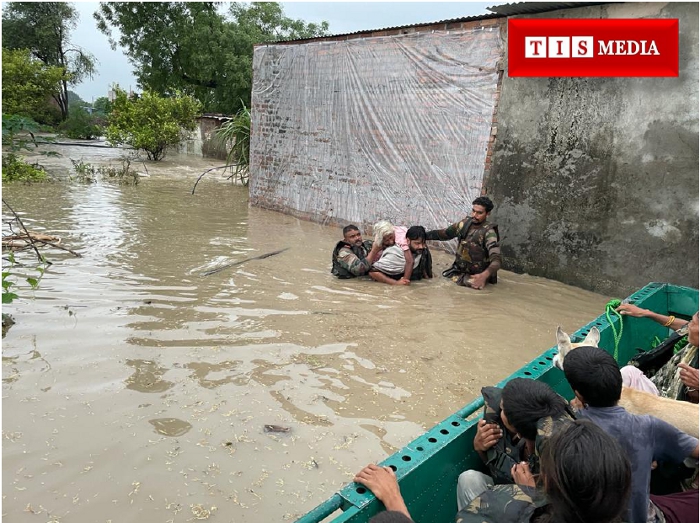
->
[456,418,631,523]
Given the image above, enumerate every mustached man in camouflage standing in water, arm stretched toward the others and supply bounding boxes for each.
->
[427,196,501,289]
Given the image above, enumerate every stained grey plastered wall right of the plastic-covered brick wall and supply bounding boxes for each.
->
[485,3,698,296]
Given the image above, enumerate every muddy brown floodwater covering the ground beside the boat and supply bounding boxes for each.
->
[2,141,608,523]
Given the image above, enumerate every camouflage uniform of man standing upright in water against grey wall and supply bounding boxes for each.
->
[426,218,501,287]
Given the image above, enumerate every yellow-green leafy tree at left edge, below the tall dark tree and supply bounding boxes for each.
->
[2,49,64,117]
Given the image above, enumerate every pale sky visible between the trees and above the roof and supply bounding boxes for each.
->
[67,1,492,102]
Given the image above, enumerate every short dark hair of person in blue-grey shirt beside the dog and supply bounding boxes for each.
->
[564,347,622,407]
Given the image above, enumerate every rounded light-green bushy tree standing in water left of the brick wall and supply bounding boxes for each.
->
[106,89,201,161]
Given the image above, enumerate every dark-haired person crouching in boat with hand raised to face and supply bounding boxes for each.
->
[457,378,574,510]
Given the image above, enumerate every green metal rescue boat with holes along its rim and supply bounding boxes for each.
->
[297,283,698,523]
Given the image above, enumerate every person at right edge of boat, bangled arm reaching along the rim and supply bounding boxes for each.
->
[616,303,699,403]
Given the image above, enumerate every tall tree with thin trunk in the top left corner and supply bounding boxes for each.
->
[2,2,95,119]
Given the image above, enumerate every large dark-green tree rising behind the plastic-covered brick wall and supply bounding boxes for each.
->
[94,2,328,114]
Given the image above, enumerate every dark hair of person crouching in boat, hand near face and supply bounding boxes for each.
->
[501,378,568,441]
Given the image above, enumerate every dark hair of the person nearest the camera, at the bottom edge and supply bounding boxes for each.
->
[540,420,632,523]
